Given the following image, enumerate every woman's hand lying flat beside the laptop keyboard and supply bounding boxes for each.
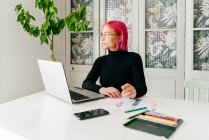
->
[99,87,121,98]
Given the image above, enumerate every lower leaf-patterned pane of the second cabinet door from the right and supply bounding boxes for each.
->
[145,31,177,69]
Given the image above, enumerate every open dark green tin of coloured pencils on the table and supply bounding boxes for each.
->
[123,109,183,138]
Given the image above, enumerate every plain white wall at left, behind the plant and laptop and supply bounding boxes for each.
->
[0,0,50,103]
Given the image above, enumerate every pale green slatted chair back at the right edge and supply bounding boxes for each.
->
[184,80,209,102]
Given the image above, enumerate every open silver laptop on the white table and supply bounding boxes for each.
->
[37,60,106,104]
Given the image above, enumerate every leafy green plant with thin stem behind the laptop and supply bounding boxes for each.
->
[15,0,89,61]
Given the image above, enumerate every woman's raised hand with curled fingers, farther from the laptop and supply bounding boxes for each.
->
[121,83,136,98]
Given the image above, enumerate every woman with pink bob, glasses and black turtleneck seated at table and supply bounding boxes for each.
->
[82,21,147,98]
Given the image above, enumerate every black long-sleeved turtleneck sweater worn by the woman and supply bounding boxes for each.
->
[82,51,147,98]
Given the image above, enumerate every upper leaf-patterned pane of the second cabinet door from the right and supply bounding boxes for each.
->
[145,0,177,29]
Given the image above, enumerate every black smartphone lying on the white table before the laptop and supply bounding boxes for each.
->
[74,108,109,120]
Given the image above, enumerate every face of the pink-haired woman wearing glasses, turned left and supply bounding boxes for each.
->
[100,25,117,51]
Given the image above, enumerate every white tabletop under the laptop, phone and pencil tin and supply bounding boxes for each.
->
[0,92,209,140]
